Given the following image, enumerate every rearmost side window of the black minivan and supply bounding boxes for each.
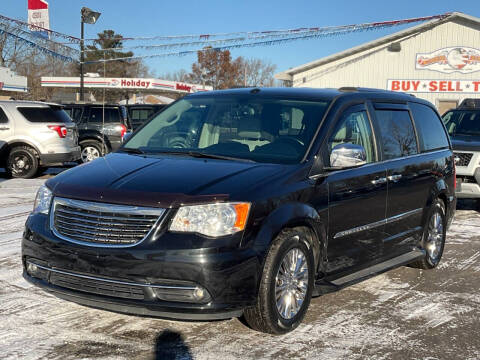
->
[410,103,449,151]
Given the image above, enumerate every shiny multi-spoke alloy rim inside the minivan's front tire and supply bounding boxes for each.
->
[275,248,308,320]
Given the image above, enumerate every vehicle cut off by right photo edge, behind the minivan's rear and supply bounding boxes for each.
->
[443,99,480,207]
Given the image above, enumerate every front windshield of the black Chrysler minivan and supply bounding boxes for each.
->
[124,96,329,164]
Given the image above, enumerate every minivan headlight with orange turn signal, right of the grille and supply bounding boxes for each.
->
[170,203,250,237]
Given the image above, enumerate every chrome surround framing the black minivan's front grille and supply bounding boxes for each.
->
[49,197,166,248]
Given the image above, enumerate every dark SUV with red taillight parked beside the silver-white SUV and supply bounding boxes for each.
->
[64,104,131,163]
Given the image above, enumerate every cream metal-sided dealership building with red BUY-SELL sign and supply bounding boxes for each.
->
[275,13,480,113]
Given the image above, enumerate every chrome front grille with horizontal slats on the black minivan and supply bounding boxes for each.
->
[50,197,165,247]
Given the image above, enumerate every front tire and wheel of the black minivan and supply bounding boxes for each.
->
[244,228,315,335]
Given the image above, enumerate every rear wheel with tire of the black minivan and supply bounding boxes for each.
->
[411,199,447,270]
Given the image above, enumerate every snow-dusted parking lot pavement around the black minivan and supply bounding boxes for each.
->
[0,174,480,360]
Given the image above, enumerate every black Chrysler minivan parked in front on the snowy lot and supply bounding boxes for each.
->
[22,88,456,334]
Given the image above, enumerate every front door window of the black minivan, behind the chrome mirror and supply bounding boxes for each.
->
[328,110,375,162]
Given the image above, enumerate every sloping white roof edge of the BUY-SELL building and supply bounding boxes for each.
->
[275,12,480,80]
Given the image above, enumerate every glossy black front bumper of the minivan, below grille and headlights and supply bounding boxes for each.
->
[22,214,261,320]
